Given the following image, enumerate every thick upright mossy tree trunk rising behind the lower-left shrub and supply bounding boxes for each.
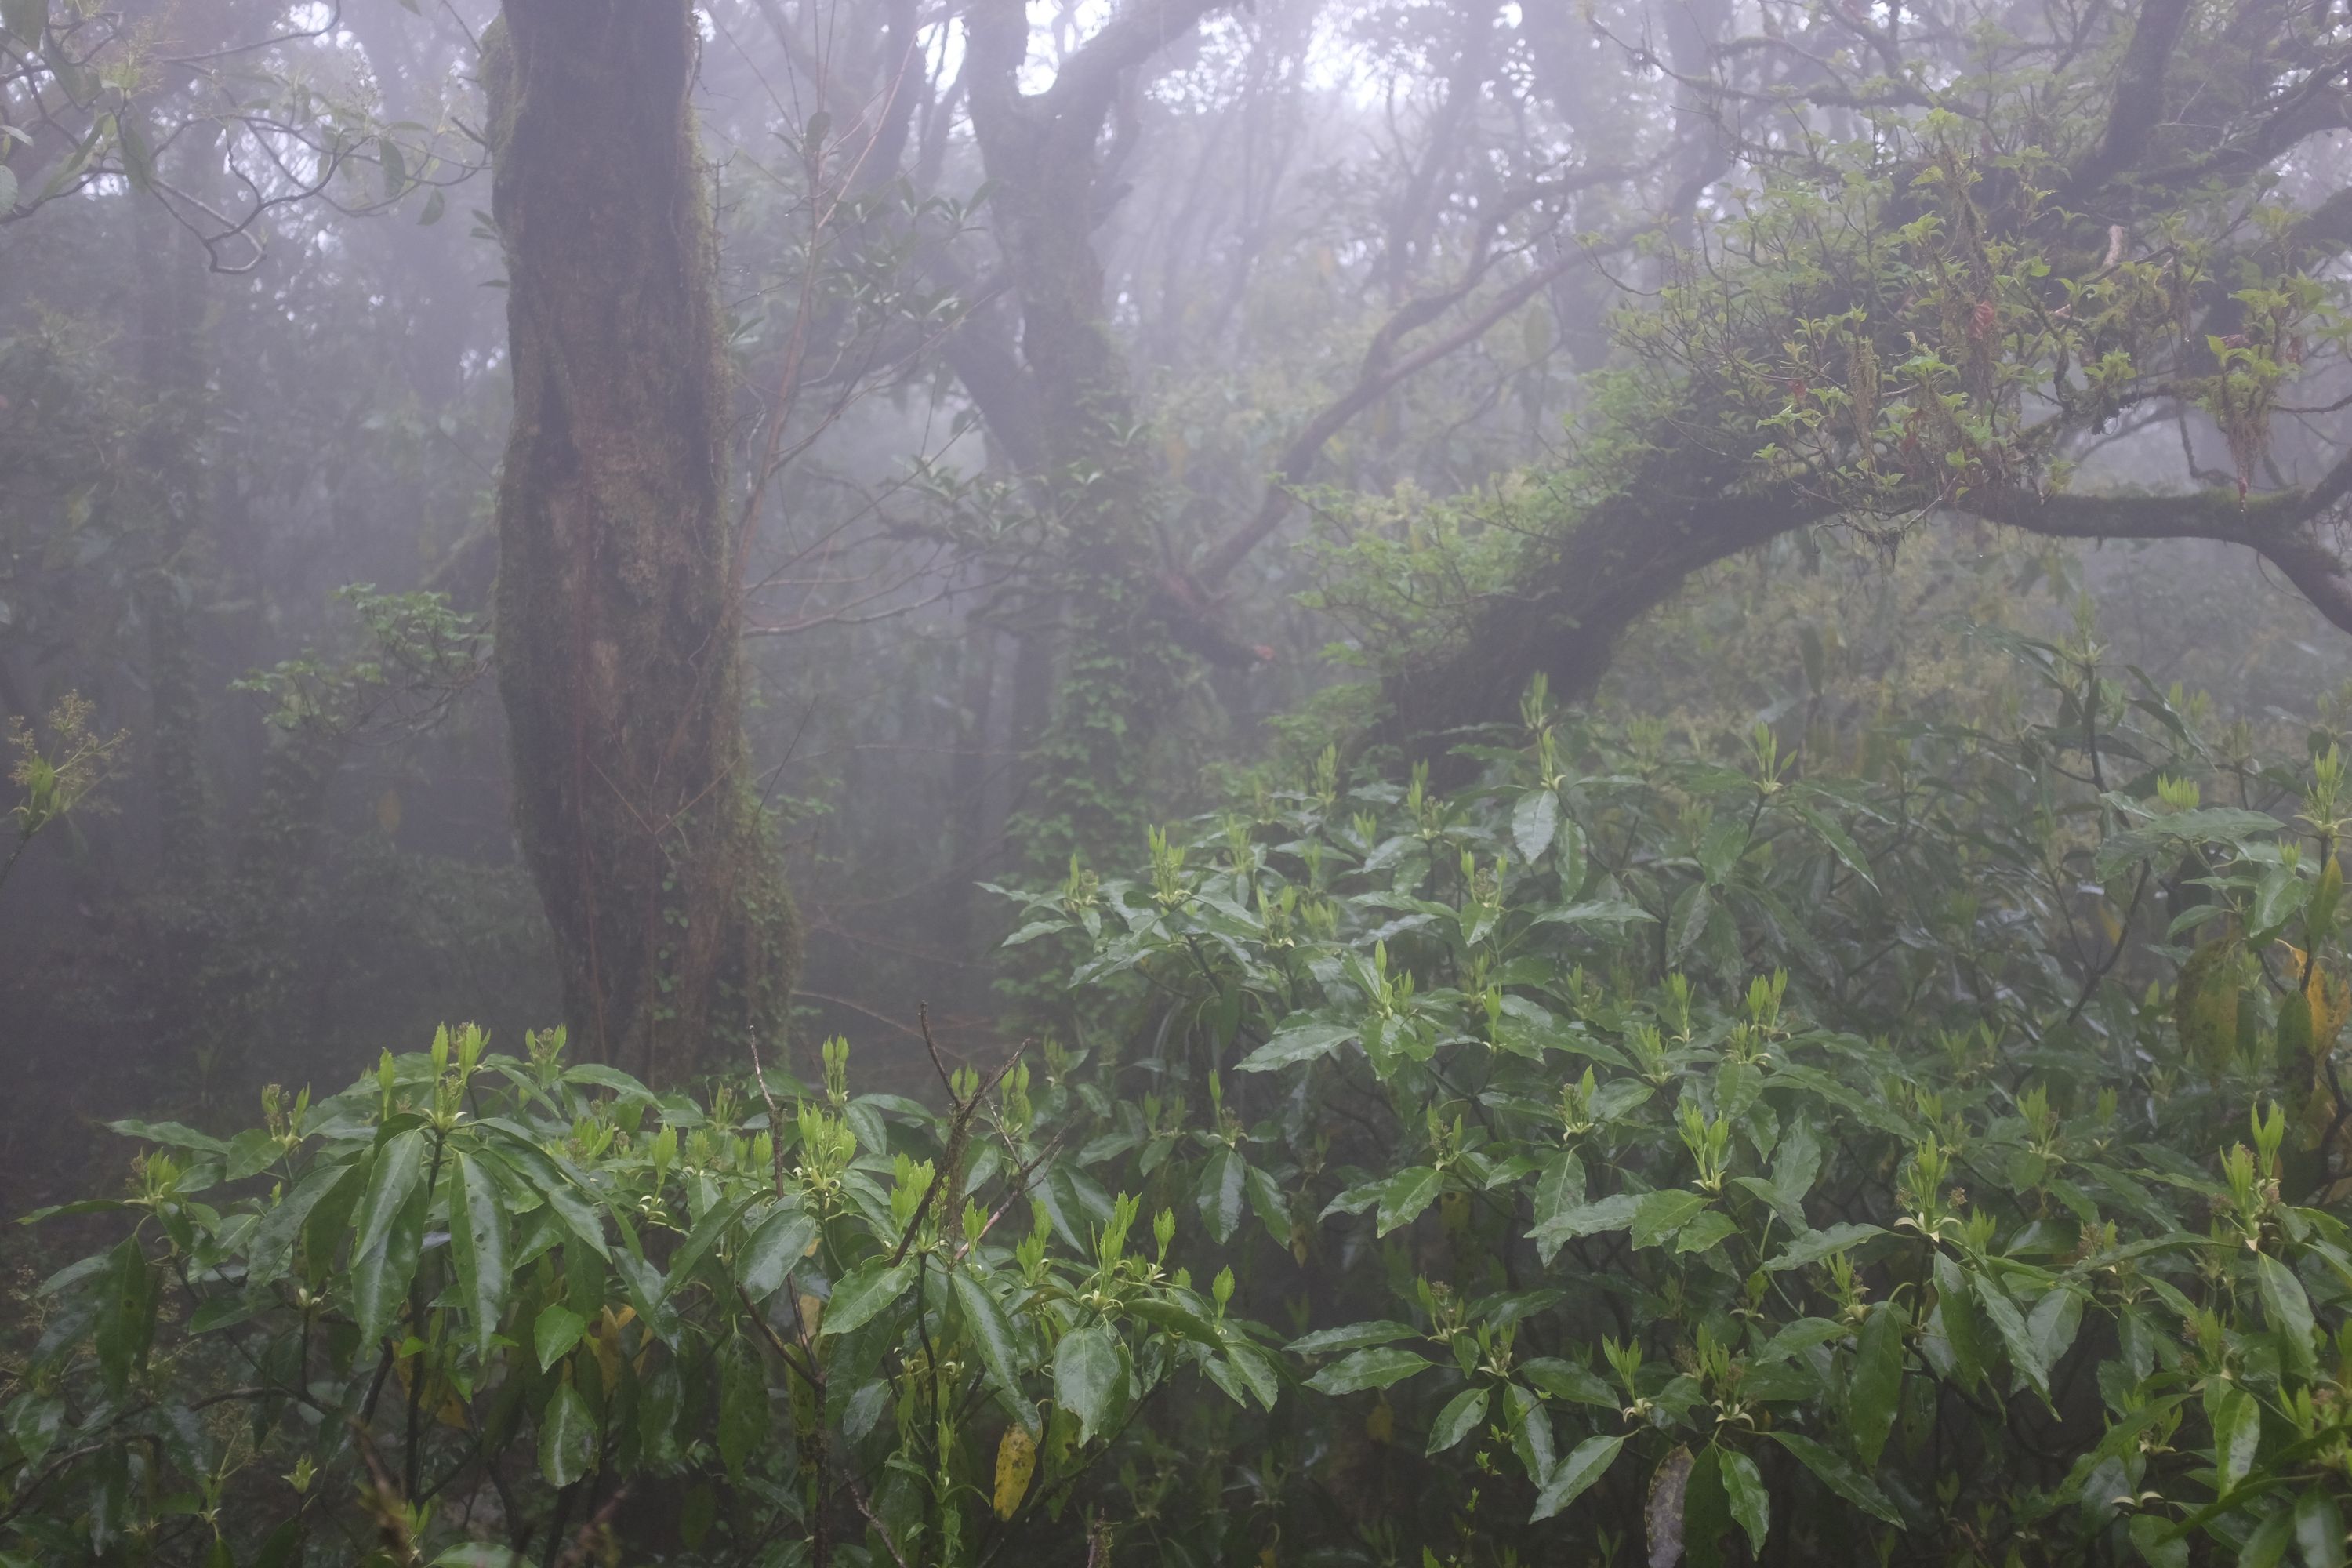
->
[485,0,797,1081]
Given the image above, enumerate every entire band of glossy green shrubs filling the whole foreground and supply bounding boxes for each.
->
[13,630,2352,1568]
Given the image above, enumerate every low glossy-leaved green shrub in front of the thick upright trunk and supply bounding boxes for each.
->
[0,1027,1277,1563]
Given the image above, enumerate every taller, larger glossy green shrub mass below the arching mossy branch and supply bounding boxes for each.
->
[983,633,2352,1563]
